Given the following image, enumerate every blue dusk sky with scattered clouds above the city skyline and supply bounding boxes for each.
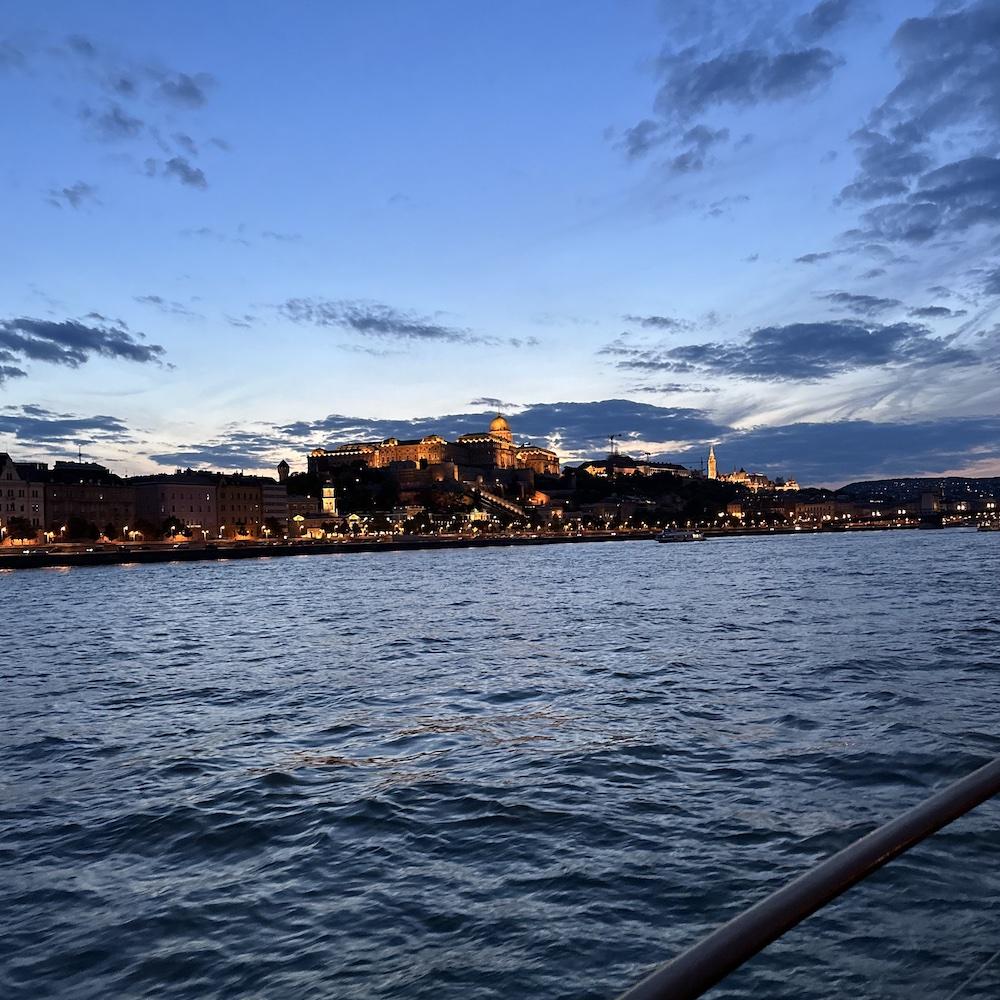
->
[0,0,1000,486]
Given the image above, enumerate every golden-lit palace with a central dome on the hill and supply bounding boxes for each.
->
[309,414,559,479]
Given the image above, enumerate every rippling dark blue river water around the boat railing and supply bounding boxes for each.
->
[0,531,1000,1000]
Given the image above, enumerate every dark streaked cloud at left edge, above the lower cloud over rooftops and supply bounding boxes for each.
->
[0,316,165,368]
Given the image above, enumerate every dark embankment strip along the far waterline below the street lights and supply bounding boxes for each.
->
[0,524,952,570]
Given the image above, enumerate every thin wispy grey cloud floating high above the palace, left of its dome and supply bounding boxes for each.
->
[278,299,488,344]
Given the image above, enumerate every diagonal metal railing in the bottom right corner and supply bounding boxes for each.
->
[619,757,1000,1000]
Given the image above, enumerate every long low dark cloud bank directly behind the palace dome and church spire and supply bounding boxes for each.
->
[145,399,1000,484]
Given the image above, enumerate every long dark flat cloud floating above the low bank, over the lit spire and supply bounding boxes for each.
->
[617,320,983,382]
